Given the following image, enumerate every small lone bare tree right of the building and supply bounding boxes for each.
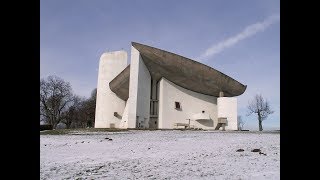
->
[247,94,274,131]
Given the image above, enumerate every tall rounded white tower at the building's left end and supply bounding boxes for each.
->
[95,51,127,128]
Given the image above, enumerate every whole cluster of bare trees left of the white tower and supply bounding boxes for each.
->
[40,76,97,129]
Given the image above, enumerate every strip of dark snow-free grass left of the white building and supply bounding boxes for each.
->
[40,128,128,135]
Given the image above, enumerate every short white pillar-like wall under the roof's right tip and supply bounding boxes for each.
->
[218,97,238,130]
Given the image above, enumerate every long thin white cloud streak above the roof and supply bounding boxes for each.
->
[196,14,280,61]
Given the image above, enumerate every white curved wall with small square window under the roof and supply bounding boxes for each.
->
[159,78,218,129]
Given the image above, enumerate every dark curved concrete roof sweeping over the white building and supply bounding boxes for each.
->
[109,42,247,100]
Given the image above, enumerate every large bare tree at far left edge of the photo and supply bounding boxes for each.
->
[40,76,73,128]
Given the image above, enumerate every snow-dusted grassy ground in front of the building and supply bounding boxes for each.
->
[40,130,280,180]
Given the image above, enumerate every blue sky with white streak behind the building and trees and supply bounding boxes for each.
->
[40,0,280,130]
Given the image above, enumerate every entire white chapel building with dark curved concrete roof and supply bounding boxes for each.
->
[95,43,246,130]
